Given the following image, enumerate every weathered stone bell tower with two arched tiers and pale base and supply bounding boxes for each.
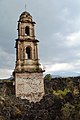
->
[14,11,44,102]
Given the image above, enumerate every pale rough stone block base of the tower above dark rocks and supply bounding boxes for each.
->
[15,72,44,102]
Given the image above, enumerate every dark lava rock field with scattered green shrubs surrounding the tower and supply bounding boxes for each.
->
[0,74,80,120]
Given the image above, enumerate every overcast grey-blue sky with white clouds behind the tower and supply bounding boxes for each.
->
[0,0,80,78]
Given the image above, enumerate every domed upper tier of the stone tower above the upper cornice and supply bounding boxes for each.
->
[18,11,35,40]
